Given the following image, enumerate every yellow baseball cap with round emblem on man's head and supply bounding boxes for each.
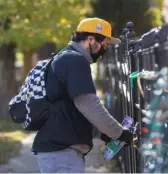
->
[77,18,121,44]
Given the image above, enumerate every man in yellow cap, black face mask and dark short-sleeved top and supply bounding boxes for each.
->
[33,18,133,173]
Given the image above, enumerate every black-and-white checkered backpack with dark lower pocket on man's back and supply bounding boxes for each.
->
[9,58,53,131]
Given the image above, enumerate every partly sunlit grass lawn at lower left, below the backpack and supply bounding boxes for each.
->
[0,117,28,164]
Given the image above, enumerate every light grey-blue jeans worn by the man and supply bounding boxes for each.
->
[37,148,85,173]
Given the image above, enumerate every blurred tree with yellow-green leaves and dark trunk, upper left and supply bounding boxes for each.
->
[0,0,89,116]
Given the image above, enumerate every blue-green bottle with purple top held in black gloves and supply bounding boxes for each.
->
[104,116,133,160]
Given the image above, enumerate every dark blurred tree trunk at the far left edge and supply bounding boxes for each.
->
[0,43,16,116]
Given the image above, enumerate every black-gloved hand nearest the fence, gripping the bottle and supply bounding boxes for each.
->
[118,129,134,145]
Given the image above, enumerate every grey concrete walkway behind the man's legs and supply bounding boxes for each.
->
[0,134,119,173]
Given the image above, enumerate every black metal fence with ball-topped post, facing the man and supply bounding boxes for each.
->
[98,22,168,173]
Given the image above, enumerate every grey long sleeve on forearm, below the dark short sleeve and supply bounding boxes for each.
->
[74,94,123,139]
